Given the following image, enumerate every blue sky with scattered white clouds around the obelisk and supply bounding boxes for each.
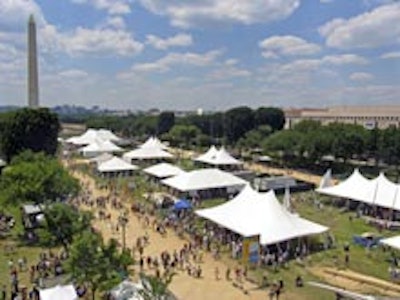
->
[0,0,400,110]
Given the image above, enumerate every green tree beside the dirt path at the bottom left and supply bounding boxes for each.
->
[66,231,133,300]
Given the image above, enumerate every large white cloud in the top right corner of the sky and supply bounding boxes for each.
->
[319,3,400,49]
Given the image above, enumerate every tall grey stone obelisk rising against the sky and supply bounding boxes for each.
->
[28,15,39,108]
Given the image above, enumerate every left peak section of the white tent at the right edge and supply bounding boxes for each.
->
[316,169,375,204]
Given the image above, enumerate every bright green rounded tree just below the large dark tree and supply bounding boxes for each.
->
[0,151,80,204]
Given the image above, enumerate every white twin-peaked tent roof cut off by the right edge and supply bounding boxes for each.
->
[316,169,400,210]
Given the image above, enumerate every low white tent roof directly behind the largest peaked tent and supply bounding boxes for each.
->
[161,169,247,192]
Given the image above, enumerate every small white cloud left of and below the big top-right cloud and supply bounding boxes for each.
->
[259,35,321,58]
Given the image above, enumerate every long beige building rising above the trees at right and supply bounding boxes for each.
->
[284,105,400,129]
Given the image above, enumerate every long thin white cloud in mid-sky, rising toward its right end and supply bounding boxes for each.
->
[132,50,222,72]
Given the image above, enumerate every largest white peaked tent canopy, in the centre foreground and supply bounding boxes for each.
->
[195,185,328,245]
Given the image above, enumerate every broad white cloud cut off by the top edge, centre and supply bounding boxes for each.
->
[139,0,300,28]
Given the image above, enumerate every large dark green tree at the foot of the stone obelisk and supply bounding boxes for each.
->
[1,108,60,161]
